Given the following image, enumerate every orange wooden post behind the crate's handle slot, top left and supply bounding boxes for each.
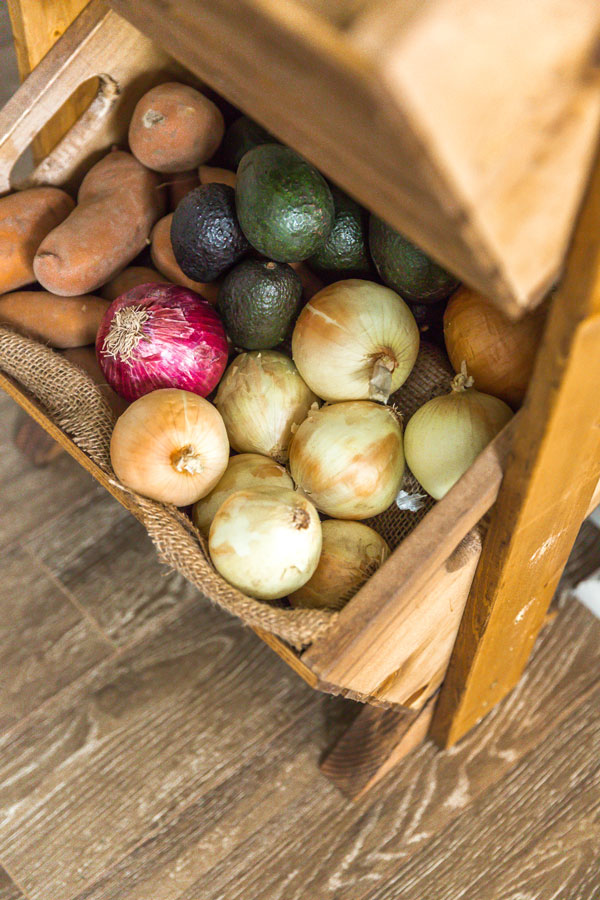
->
[8,0,98,161]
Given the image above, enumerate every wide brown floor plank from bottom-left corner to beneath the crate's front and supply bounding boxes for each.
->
[0,606,322,900]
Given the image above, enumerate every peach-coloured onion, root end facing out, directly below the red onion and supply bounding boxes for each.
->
[110,388,229,506]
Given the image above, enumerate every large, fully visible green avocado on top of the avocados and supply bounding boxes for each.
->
[235,144,334,262]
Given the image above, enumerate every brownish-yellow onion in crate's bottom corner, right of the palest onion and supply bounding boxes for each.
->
[290,519,390,609]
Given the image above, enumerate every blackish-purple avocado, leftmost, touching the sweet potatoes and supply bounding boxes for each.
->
[171,183,250,281]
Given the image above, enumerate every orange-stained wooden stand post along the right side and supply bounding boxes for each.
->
[431,151,600,746]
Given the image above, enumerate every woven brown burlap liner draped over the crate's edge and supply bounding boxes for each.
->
[0,327,464,648]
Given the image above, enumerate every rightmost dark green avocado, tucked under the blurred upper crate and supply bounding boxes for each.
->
[369,215,460,303]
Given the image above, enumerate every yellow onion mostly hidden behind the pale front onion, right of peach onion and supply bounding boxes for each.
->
[192,453,294,537]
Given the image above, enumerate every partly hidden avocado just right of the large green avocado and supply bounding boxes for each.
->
[308,185,373,278]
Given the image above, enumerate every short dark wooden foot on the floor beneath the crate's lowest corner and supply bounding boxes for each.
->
[320,696,436,800]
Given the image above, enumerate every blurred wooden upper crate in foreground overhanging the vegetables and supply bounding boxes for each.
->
[112,0,600,315]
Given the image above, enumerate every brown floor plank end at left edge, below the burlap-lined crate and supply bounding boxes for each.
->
[0,549,113,732]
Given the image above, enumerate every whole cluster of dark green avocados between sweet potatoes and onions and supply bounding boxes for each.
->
[171,116,458,350]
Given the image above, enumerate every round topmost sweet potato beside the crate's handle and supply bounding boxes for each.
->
[129,81,225,172]
